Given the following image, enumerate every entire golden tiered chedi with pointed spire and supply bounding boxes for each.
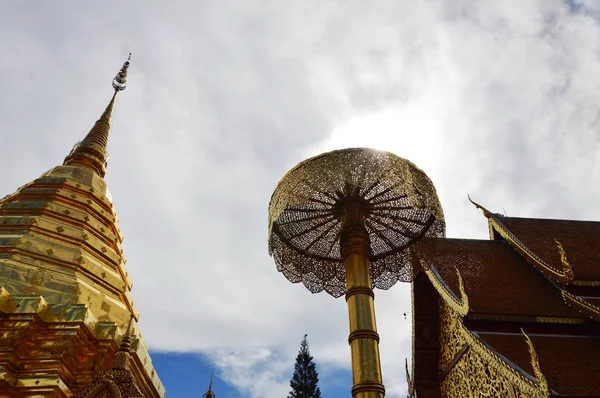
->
[0,56,165,397]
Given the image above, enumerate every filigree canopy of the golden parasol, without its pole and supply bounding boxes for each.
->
[269,148,445,297]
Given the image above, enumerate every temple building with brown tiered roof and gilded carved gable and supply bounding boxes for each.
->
[409,202,600,398]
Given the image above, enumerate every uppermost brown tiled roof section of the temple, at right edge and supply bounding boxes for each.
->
[494,215,600,281]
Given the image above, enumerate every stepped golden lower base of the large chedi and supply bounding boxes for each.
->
[0,288,166,398]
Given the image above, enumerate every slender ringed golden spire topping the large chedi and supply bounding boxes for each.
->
[63,53,131,177]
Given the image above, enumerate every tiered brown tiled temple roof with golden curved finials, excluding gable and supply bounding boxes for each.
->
[414,207,600,397]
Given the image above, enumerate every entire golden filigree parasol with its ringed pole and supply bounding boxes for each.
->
[269,148,445,398]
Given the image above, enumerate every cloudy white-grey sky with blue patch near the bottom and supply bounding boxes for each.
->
[0,0,600,398]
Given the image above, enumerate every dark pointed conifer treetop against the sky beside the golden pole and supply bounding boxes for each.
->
[288,335,321,398]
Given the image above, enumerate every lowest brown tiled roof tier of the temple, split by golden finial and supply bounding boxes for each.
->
[478,333,600,397]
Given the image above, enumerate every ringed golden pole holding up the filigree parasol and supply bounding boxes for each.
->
[340,202,385,398]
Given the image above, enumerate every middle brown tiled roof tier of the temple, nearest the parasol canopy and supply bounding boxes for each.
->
[432,239,582,318]
